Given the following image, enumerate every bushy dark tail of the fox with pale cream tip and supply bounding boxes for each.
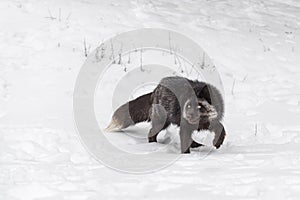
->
[105,92,152,131]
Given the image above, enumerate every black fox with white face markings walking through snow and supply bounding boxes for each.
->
[105,76,226,153]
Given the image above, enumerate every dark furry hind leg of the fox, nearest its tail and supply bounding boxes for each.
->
[148,104,170,142]
